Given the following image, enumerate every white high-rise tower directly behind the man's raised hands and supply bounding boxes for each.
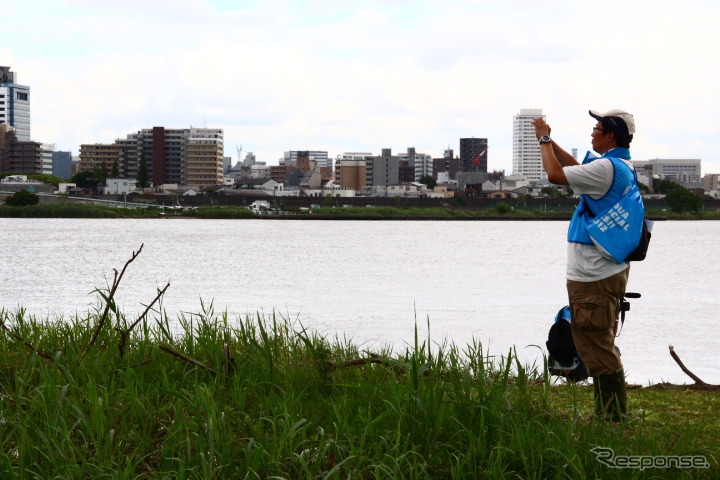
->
[513,108,547,181]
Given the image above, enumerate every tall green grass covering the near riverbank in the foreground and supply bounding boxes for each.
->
[0,247,720,480]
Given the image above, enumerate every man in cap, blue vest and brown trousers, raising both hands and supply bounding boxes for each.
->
[533,110,637,420]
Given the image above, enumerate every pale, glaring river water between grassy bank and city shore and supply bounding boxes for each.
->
[0,218,720,385]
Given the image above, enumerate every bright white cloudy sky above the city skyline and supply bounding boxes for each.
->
[0,0,720,174]
